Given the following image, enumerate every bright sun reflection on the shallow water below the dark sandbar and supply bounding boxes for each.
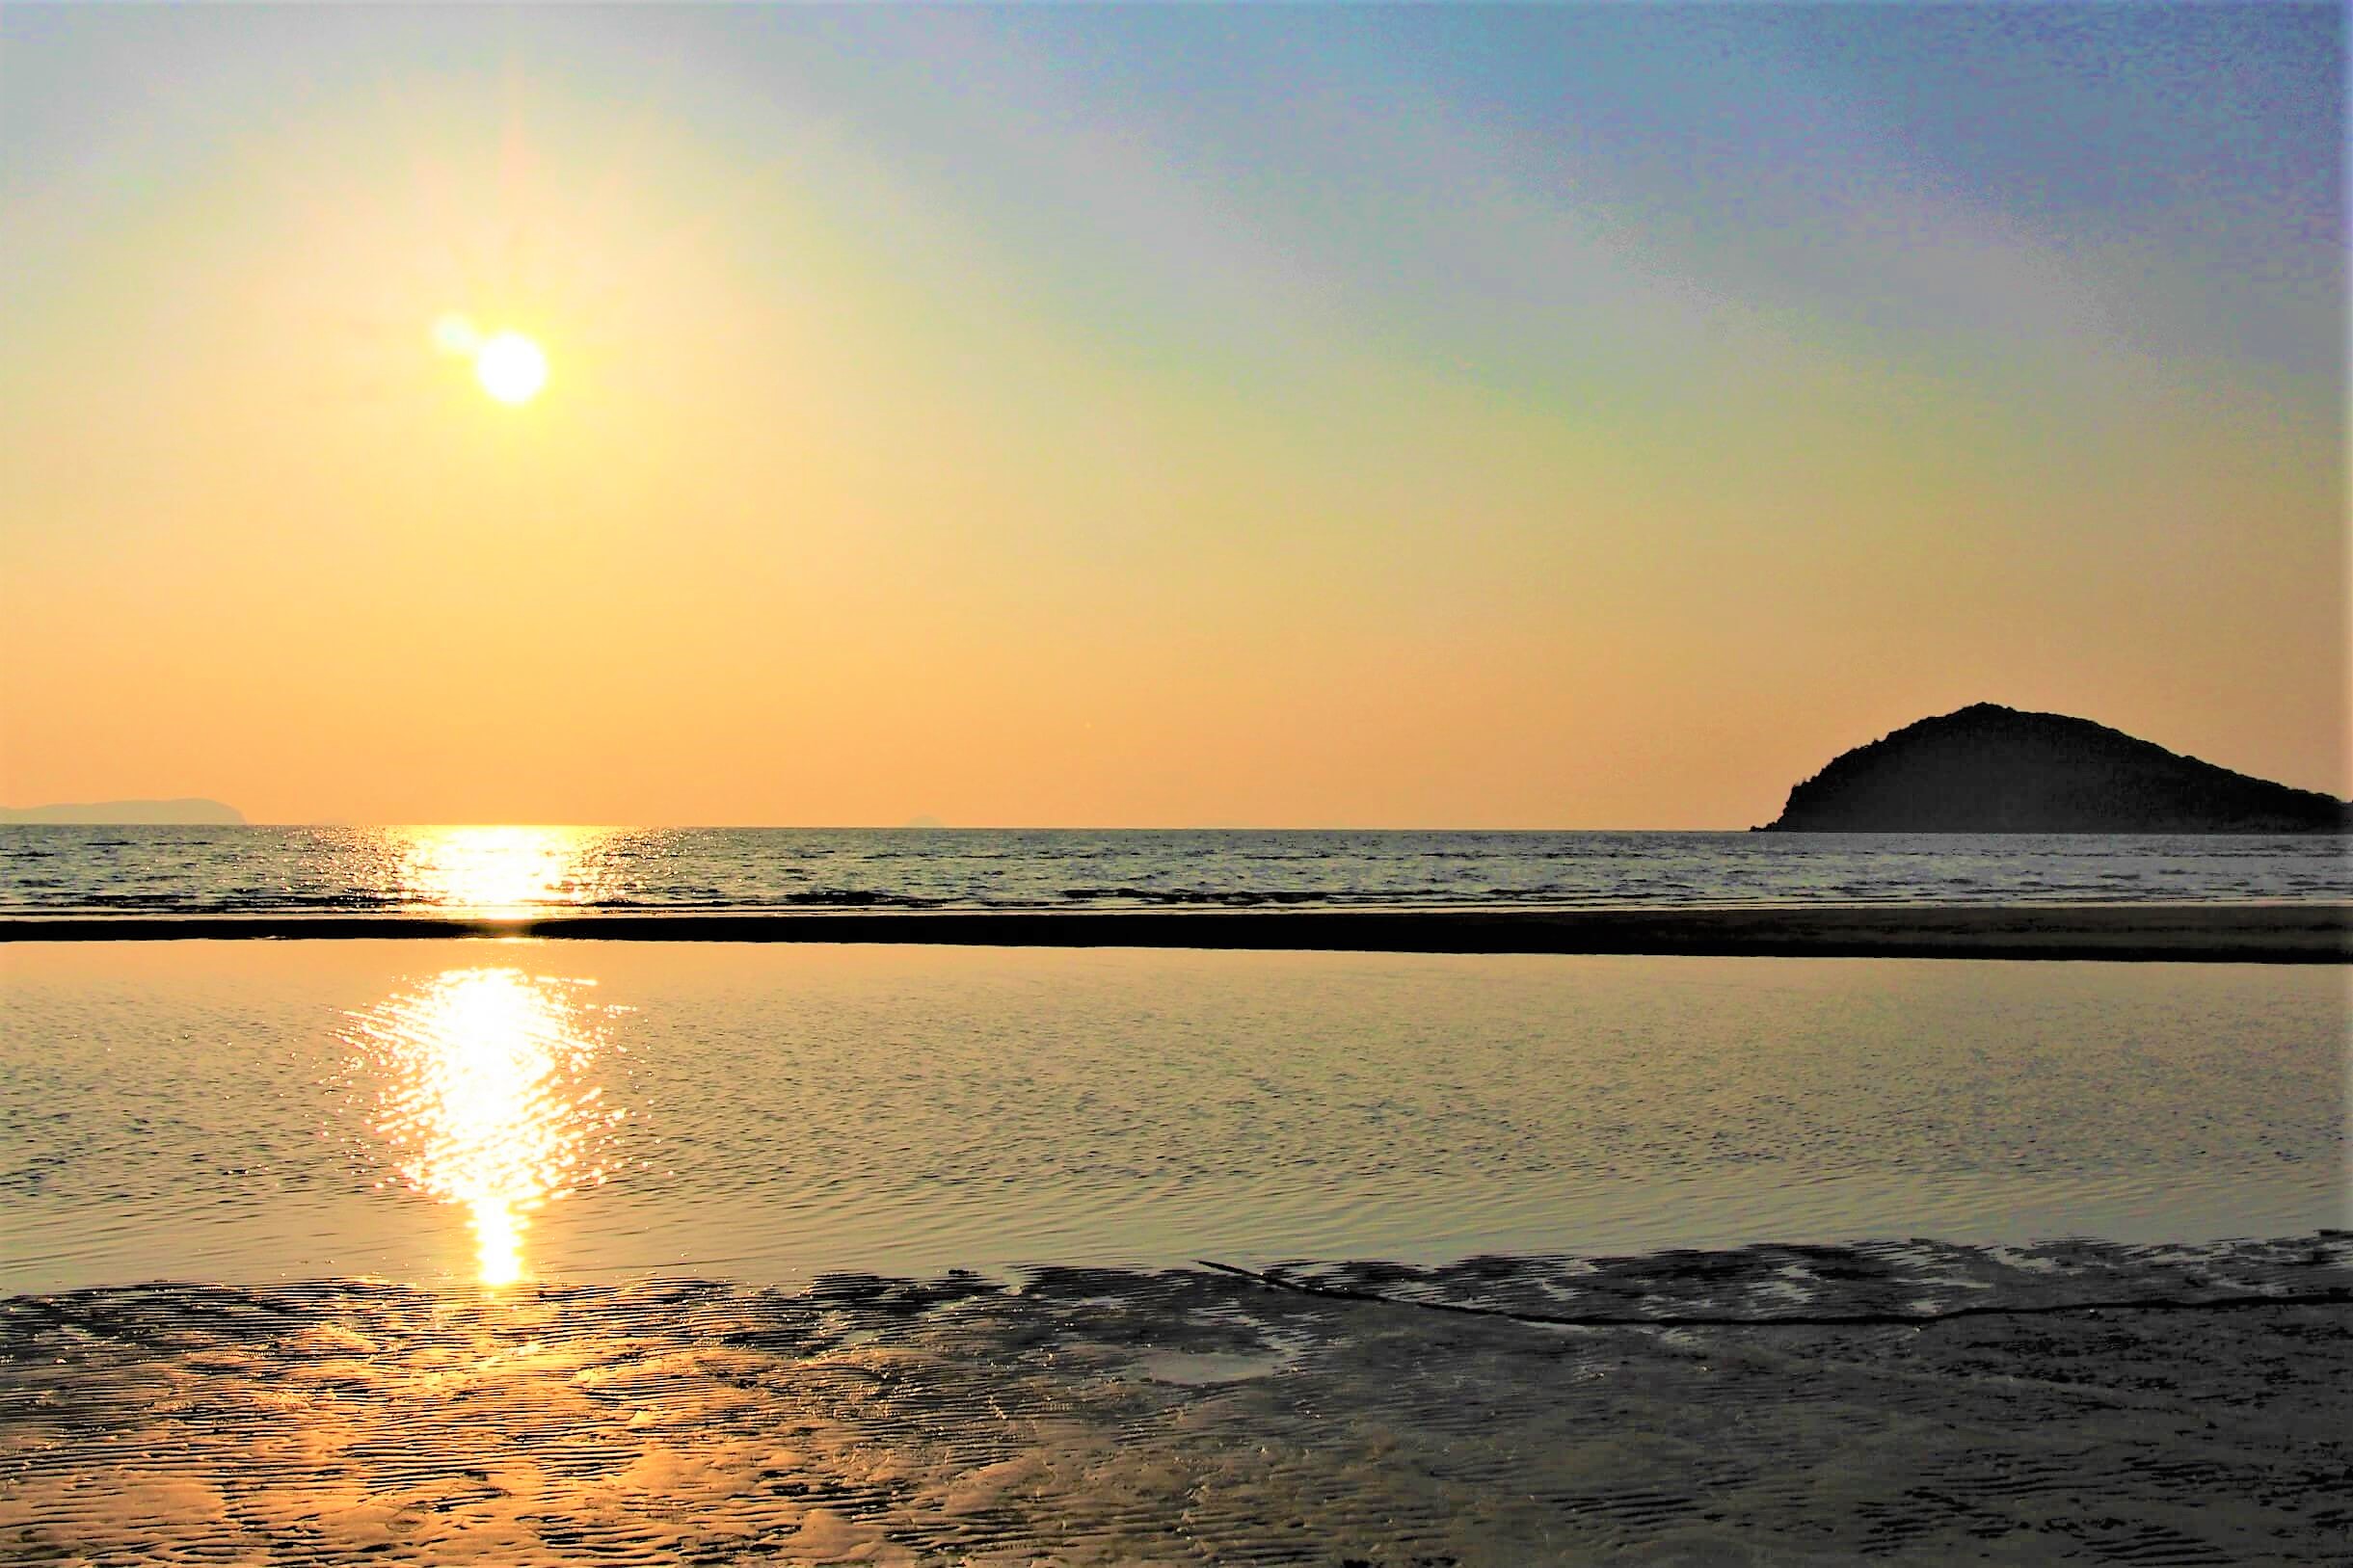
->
[346,969,626,1286]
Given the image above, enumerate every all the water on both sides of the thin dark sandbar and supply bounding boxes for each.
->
[0,825,2353,1289]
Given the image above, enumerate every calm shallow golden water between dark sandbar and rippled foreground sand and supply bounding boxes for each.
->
[0,938,2346,1293]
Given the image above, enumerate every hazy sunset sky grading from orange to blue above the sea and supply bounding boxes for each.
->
[0,5,2353,828]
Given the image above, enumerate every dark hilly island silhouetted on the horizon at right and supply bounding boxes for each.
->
[1757,703,2353,833]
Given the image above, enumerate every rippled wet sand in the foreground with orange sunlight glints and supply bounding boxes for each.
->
[0,1232,2353,1568]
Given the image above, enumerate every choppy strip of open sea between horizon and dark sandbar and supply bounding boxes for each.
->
[0,828,2353,915]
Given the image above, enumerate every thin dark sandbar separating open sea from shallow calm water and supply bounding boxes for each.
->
[0,903,2353,964]
